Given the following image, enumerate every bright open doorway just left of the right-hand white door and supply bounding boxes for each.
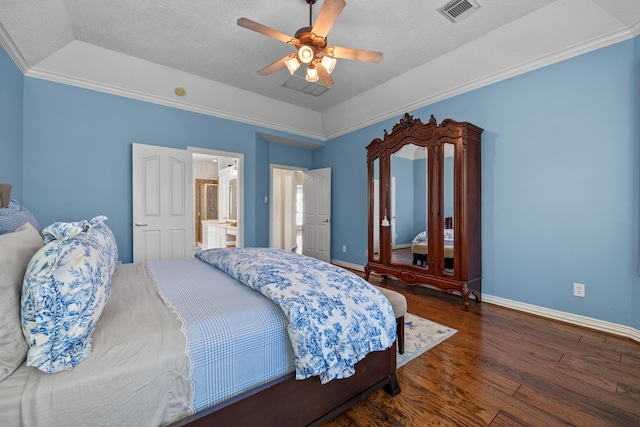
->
[270,165,304,254]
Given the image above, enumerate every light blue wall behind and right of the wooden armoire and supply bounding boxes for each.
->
[314,39,640,328]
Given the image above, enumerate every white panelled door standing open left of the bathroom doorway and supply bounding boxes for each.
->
[132,144,194,262]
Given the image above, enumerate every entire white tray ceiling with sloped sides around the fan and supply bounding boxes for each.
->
[0,0,640,140]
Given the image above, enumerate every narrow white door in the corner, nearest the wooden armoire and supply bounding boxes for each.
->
[302,168,331,262]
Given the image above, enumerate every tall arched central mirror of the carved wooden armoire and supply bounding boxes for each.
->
[390,144,429,269]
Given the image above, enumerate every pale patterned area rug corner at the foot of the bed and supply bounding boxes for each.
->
[396,313,458,368]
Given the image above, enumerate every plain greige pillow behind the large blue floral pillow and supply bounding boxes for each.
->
[0,223,44,381]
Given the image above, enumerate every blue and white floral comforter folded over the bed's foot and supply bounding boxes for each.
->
[196,248,396,384]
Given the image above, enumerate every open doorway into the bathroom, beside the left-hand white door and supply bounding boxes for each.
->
[192,150,243,249]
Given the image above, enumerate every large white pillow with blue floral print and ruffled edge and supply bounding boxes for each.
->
[21,221,117,373]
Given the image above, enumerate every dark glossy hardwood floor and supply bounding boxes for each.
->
[326,275,640,427]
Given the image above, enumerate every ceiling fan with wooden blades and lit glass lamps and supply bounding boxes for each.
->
[238,0,382,87]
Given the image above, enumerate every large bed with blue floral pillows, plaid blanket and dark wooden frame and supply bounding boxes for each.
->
[0,211,400,426]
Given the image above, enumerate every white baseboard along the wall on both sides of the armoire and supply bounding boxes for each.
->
[331,260,640,342]
